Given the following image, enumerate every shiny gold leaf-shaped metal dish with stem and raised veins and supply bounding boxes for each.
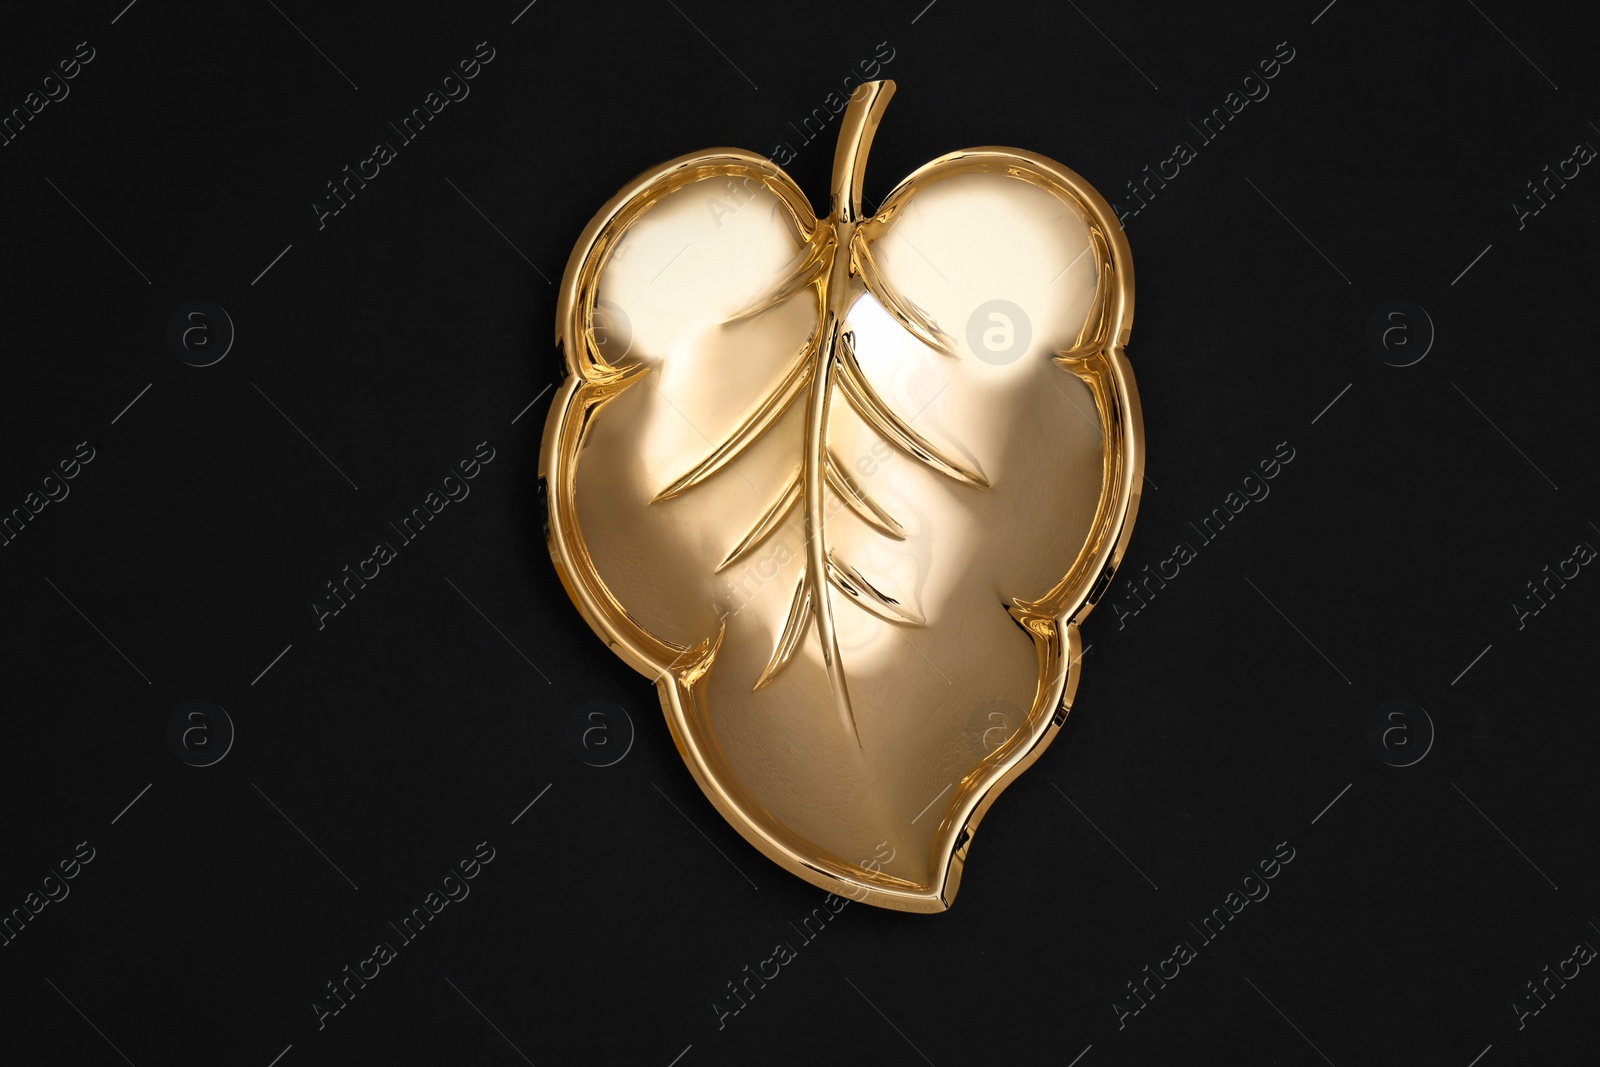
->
[539,82,1144,912]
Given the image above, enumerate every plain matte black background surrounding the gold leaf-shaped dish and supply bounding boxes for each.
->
[0,0,1600,1067]
